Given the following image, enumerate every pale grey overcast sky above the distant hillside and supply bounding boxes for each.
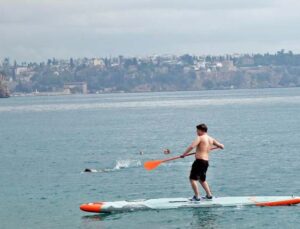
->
[0,0,300,61]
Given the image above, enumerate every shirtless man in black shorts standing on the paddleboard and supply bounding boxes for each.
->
[181,124,224,201]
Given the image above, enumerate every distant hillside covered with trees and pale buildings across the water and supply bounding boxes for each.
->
[0,50,300,94]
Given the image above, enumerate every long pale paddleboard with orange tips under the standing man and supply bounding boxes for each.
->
[80,196,300,213]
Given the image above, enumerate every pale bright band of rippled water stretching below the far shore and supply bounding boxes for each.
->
[0,96,300,112]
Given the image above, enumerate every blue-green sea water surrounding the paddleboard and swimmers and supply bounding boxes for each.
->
[0,88,300,228]
